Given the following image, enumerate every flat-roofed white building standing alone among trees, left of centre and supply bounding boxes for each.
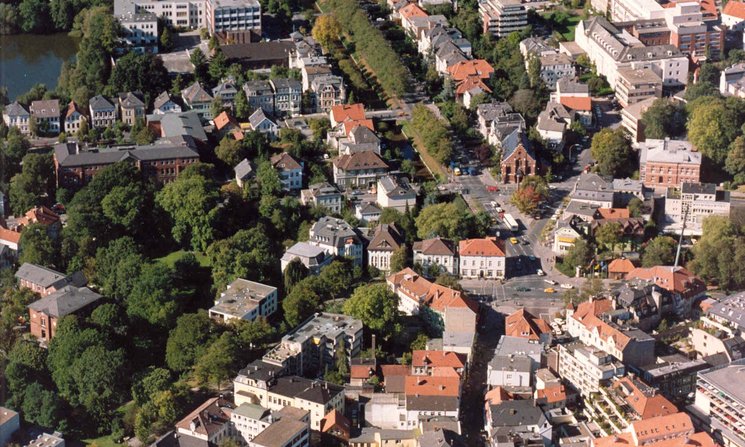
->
[209,278,279,323]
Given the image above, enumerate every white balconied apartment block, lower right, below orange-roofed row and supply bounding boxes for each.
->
[556,341,625,397]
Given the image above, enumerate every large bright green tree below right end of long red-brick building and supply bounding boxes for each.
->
[156,165,219,251]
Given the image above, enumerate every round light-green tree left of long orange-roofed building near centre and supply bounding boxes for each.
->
[344,284,401,340]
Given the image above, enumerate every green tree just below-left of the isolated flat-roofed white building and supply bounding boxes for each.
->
[166,312,214,373]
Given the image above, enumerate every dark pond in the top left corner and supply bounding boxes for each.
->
[0,33,78,101]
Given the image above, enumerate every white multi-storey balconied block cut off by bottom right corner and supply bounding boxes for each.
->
[689,359,745,447]
